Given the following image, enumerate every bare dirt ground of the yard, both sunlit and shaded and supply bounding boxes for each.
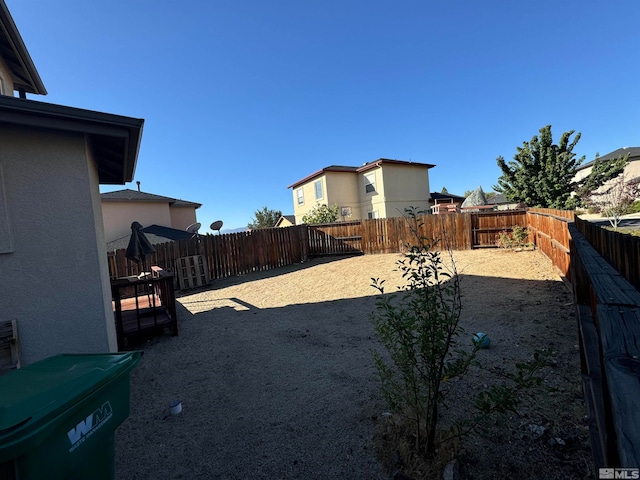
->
[116,250,592,479]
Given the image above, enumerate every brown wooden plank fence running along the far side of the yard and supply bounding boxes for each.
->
[108,210,568,279]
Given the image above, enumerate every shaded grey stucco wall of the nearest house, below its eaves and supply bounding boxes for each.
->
[0,123,117,364]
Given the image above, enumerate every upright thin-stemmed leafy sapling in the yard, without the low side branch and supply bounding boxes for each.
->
[371,209,470,455]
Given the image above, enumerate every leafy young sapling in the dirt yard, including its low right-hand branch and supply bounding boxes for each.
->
[371,209,551,464]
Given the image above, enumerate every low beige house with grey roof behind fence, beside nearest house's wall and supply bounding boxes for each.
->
[100,189,202,243]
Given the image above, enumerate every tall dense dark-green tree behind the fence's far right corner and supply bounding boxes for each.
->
[493,125,585,208]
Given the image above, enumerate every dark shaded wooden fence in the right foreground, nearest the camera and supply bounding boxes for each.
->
[569,222,640,468]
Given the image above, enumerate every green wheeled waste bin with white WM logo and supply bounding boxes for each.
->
[0,352,142,480]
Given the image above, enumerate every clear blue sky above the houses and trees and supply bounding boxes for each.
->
[6,0,640,231]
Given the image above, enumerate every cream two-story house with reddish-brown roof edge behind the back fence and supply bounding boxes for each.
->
[287,158,435,224]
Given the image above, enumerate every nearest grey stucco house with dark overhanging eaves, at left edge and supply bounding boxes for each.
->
[0,0,144,365]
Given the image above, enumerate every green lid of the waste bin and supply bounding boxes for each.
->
[0,351,142,436]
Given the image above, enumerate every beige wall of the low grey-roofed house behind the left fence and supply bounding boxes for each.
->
[102,201,172,242]
